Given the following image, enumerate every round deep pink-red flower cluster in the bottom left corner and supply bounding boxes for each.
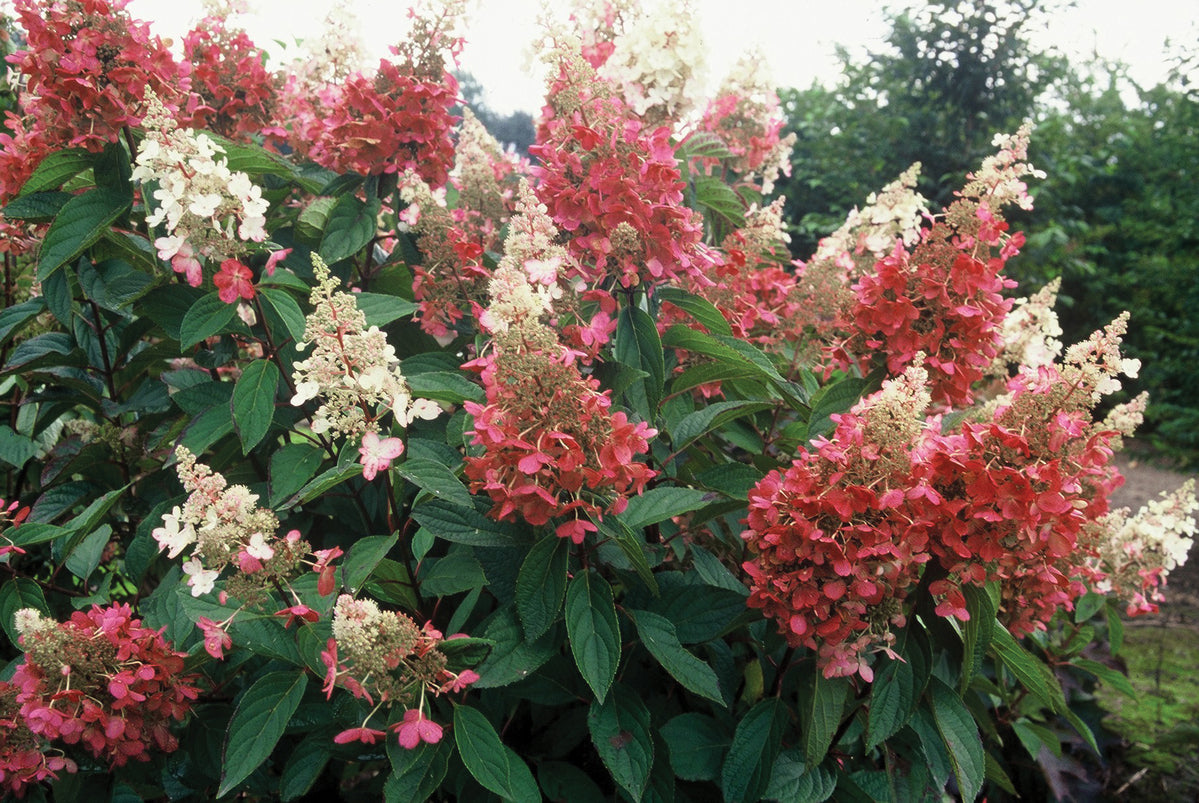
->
[12,604,199,767]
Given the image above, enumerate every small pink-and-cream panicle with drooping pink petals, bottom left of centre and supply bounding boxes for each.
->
[321,594,478,749]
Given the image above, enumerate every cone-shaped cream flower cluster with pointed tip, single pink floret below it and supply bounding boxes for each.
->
[291,254,441,436]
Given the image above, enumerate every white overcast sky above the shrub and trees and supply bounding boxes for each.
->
[128,0,1199,113]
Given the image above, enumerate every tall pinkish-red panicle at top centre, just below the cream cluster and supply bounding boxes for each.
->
[529,52,712,288]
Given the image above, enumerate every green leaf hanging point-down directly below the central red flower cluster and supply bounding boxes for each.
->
[566,570,620,702]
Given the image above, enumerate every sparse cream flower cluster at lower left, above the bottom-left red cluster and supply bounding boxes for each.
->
[150,446,279,597]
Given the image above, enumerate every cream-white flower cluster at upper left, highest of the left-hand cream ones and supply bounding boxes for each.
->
[133,90,269,284]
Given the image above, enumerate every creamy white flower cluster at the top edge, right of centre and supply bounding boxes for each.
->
[600,0,707,122]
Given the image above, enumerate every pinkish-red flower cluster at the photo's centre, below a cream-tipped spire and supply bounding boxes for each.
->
[464,350,657,544]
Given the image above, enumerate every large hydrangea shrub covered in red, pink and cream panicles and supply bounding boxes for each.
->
[0,0,1199,801]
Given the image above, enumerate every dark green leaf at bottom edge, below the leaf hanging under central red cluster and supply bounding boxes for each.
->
[588,683,653,801]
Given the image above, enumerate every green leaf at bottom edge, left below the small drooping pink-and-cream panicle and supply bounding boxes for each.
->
[217,671,308,797]
